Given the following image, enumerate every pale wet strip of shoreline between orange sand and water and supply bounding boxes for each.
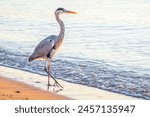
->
[0,66,140,100]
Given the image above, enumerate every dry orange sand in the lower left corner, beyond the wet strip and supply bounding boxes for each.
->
[0,77,68,100]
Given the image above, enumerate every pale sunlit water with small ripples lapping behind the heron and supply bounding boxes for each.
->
[0,0,150,99]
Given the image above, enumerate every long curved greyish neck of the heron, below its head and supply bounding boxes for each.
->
[55,13,65,39]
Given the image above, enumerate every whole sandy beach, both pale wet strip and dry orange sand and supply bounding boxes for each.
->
[0,66,139,100]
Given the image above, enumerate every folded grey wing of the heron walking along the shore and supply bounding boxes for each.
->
[32,35,57,58]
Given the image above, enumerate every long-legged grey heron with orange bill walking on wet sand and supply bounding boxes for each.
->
[29,8,76,90]
